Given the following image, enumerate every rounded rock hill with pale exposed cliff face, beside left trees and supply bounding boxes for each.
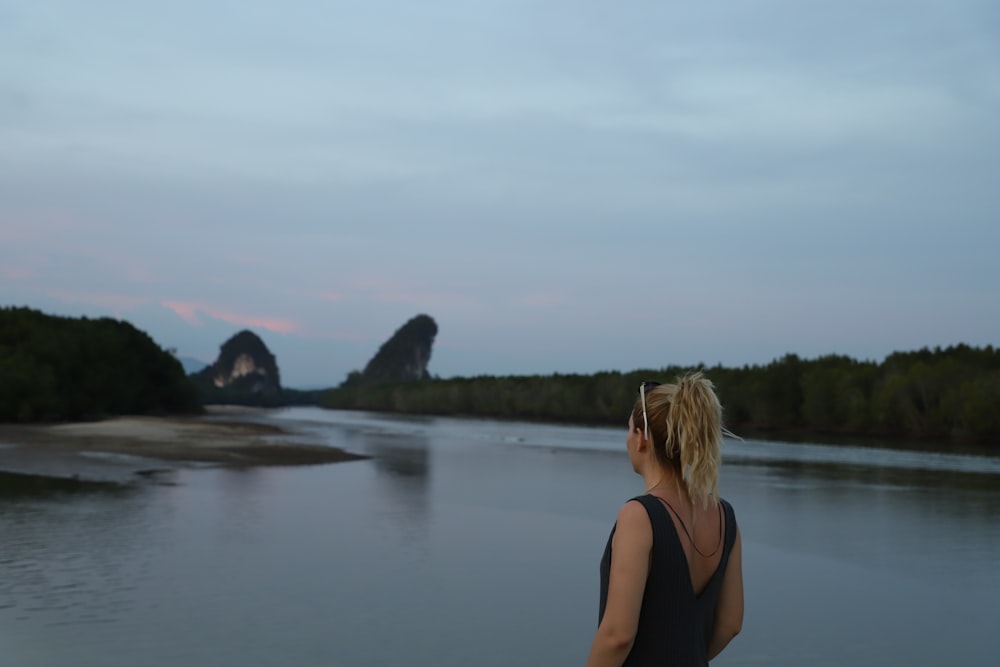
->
[191,330,281,403]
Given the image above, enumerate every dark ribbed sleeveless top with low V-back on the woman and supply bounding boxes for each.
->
[598,495,736,667]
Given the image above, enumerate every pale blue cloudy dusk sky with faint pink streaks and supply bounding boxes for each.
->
[0,0,1000,387]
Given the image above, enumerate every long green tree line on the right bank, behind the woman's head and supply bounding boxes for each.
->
[323,345,1000,445]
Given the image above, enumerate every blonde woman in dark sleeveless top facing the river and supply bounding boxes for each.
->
[587,373,743,667]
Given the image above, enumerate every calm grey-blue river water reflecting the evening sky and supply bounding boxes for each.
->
[0,408,1000,667]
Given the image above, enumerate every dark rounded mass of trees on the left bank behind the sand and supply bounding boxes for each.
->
[0,308,201,422]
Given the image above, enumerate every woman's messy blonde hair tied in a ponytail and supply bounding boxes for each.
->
[632,372,725,507]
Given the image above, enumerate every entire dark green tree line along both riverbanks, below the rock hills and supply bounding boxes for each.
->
[0,308,1000,446]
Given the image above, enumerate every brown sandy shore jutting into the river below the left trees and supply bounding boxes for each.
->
[0,411,367,477]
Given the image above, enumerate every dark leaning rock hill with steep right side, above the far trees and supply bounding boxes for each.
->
[345,315,438,386]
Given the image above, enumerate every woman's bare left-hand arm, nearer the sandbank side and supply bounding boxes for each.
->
[587,502,653,667]
